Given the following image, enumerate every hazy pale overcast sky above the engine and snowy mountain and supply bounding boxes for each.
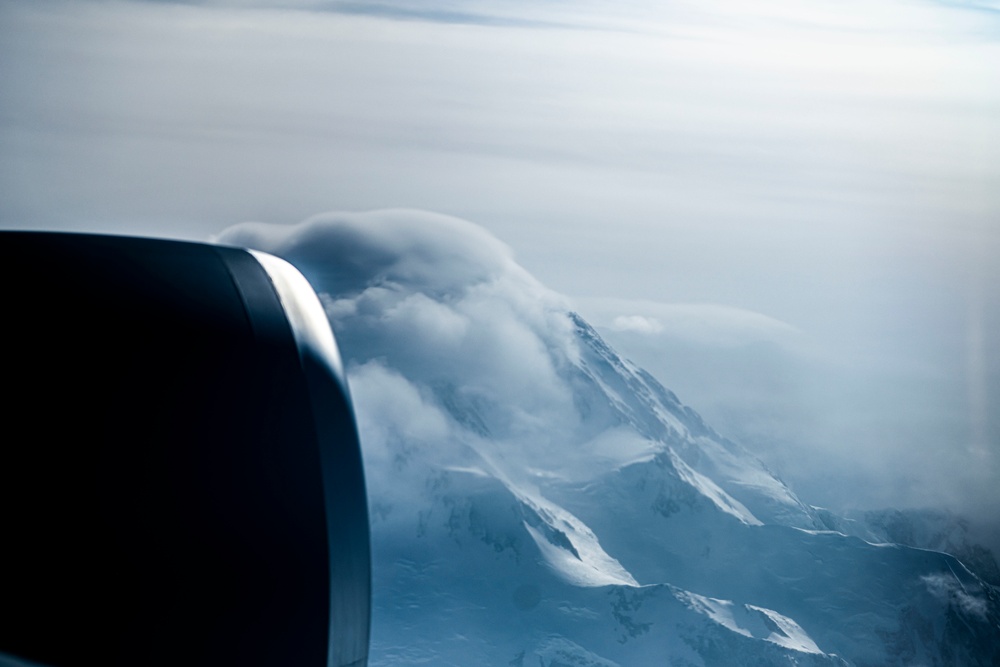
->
[0,0,1000,536]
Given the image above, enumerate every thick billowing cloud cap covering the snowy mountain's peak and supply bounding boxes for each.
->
[218,210,579,462]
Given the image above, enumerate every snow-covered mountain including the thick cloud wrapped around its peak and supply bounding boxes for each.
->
[220,211,1000,667]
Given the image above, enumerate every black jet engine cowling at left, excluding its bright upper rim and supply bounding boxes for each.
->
[0,232,370,667]
